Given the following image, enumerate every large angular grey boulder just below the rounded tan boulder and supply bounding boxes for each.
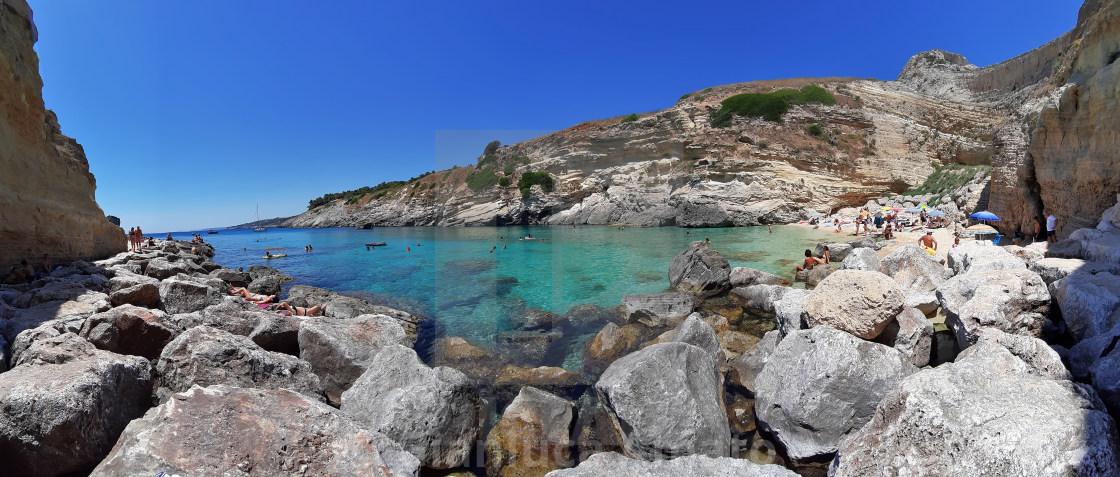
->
[755,326,916,461]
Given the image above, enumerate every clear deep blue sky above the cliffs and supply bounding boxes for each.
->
[30,0,1081,232]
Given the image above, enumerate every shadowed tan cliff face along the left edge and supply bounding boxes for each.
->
[0,0,124,264]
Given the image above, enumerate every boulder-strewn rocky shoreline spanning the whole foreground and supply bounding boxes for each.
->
[0,194,1120,476]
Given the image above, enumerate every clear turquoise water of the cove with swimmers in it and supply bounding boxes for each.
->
[179,226,832,347]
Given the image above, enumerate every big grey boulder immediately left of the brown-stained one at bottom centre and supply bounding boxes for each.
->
[340,345,484,469]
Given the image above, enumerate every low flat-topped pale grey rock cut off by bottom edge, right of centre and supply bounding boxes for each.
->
[547,452,797,477]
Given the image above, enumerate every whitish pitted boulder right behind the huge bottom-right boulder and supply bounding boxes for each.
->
[937,269,1051,349]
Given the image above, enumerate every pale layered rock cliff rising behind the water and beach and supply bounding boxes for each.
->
[286,1,1120,237]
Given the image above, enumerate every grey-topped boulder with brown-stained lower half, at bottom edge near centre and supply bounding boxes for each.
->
[486,386,573,477]
